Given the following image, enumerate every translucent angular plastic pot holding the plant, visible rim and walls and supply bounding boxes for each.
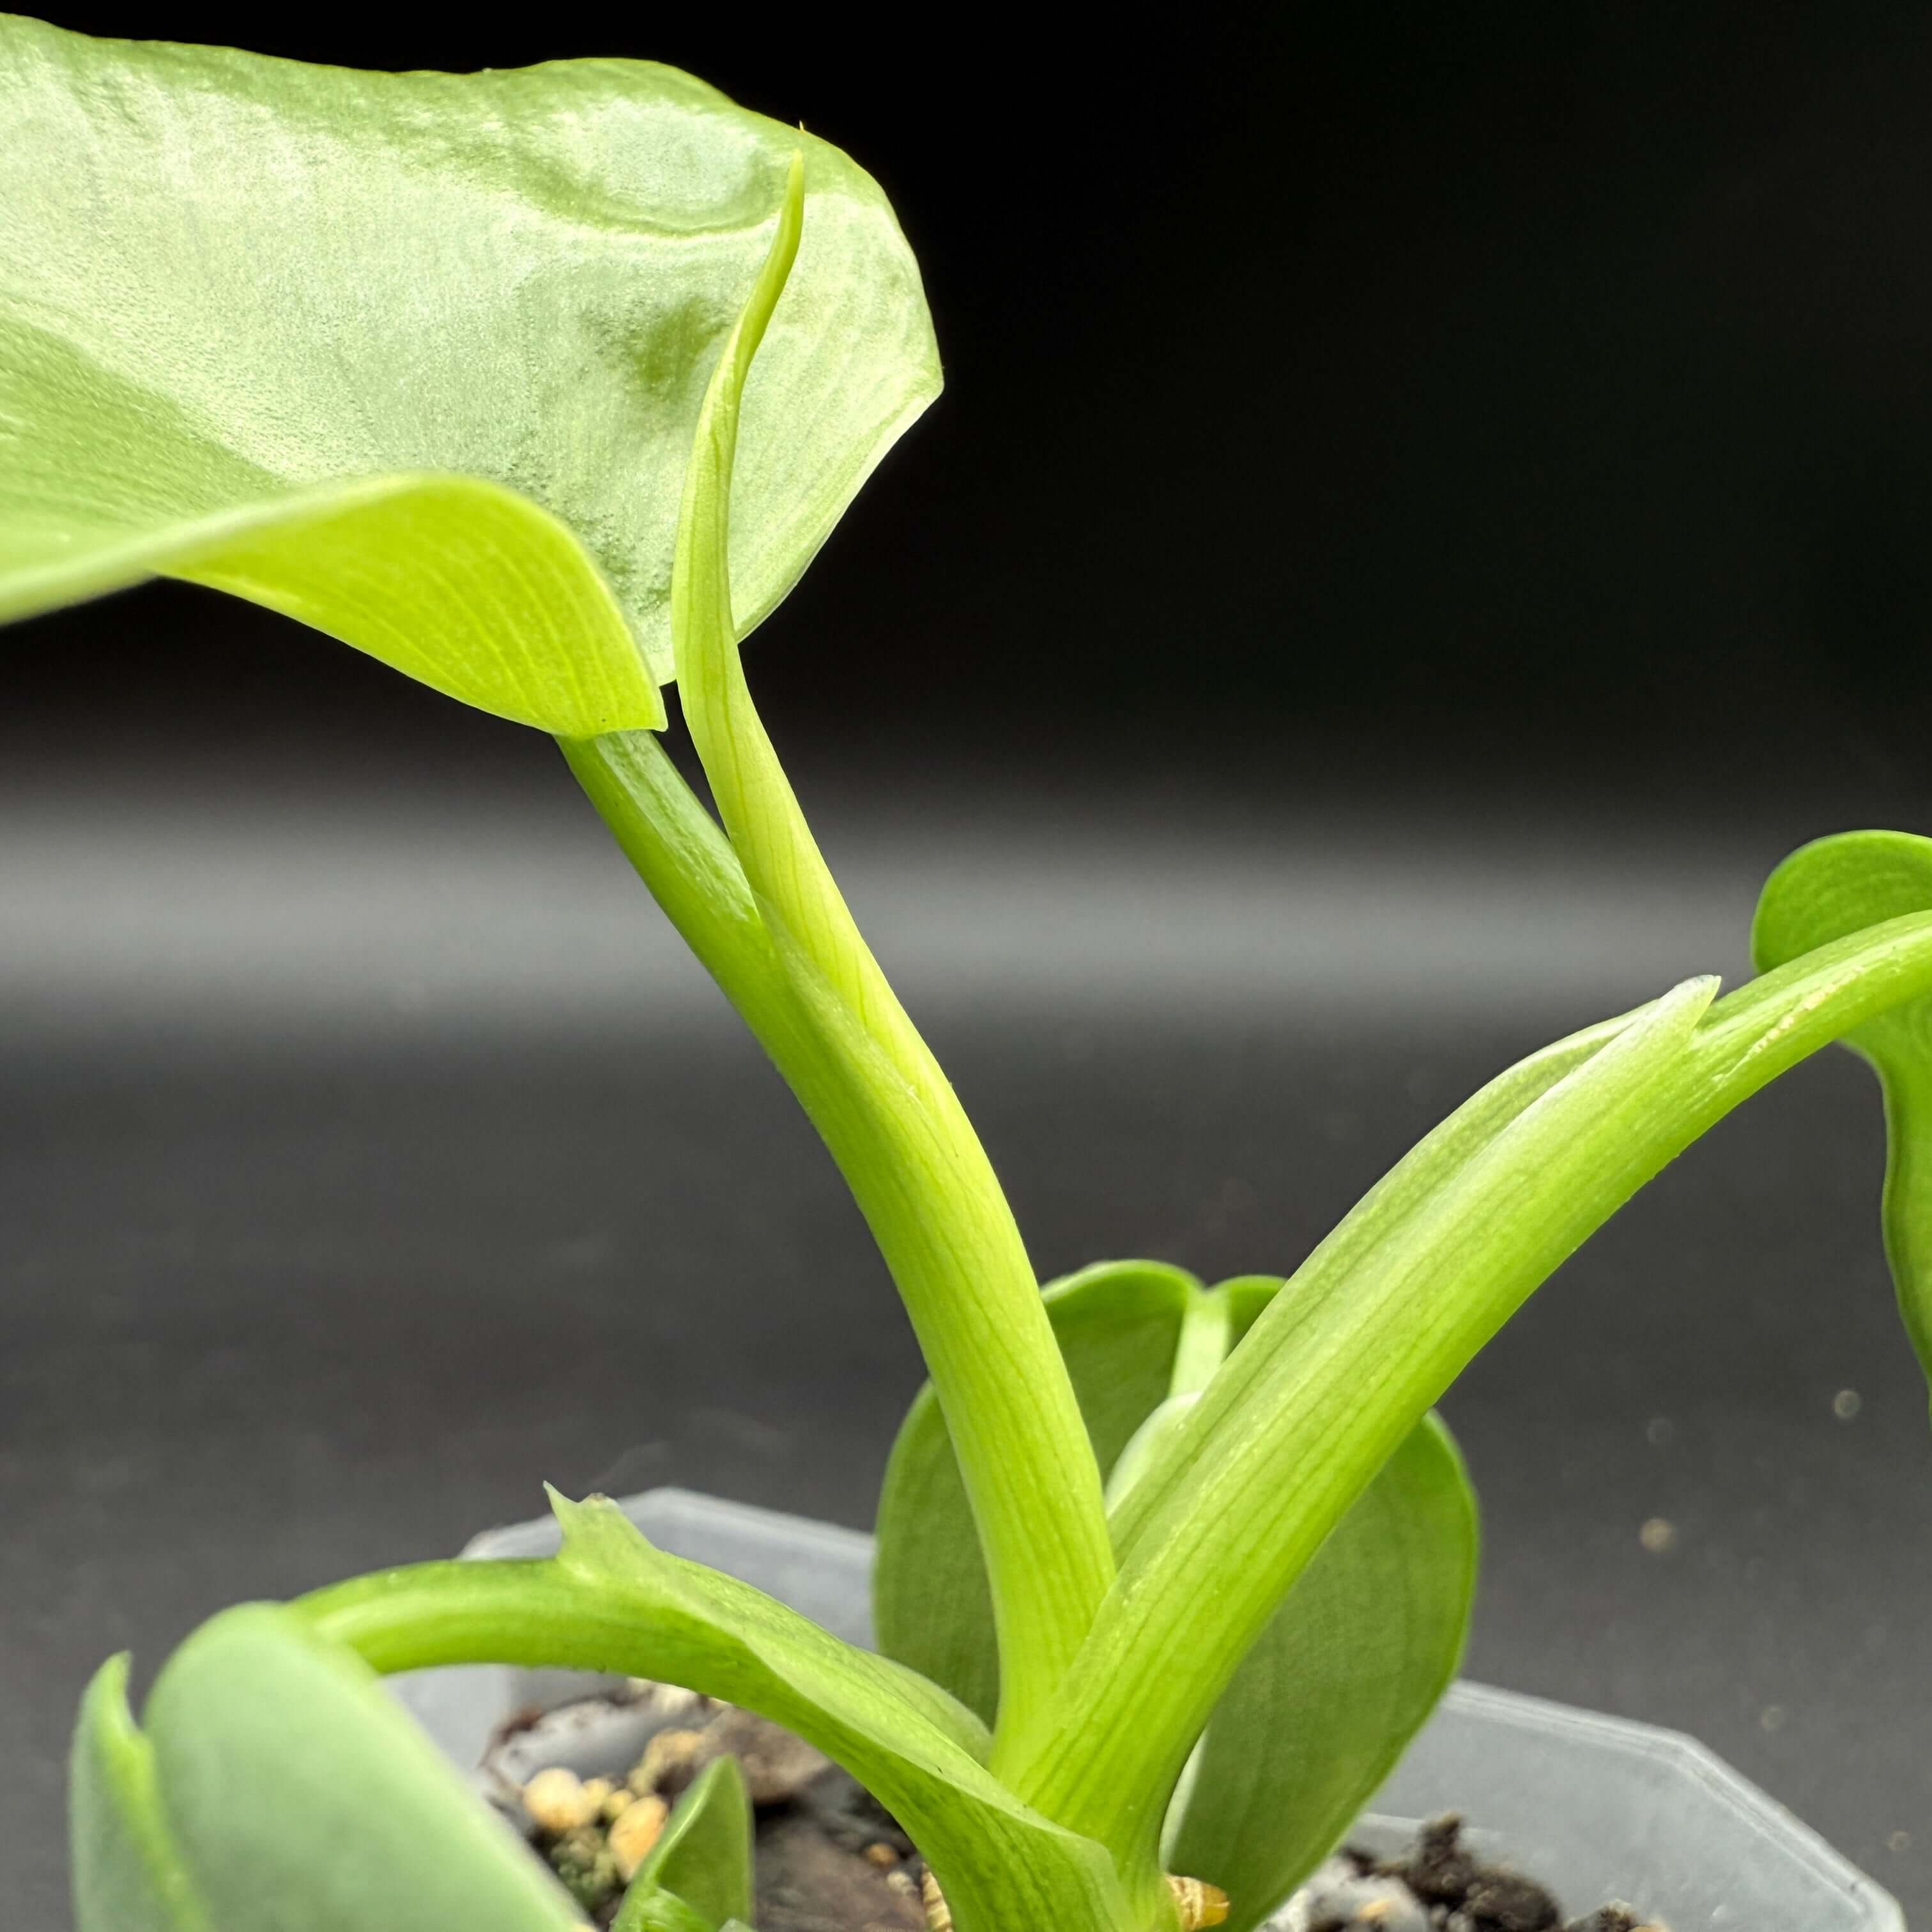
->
[396,1490,1905,1932]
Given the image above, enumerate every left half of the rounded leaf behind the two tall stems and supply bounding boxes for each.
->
[871,1262,1200,1723]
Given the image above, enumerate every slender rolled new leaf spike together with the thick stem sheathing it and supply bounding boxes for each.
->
[645,168,1115,1754]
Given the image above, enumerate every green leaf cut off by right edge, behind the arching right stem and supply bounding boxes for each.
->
[1751,832,1932,1379]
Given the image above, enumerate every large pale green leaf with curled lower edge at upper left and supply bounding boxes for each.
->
[0,17,939,736]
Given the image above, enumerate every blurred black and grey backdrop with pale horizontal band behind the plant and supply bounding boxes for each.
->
[0,4,1932,1926]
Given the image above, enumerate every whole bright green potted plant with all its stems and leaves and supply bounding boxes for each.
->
[15,19,1932,1932]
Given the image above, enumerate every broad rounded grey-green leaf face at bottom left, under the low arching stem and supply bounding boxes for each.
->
[145,1604,583,1932]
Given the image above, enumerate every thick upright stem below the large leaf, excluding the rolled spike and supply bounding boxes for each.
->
[564,732,1113,1754]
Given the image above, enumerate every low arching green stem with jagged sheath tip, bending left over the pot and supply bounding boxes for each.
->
[294,1494,1128,1932]
